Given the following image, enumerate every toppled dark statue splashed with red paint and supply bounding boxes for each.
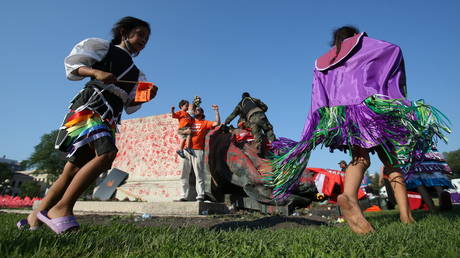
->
[204,126,364,214]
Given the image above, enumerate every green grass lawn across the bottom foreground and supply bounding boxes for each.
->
[0,208,460,257]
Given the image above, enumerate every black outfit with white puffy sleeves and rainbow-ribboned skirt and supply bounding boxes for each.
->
[55,38,145,160]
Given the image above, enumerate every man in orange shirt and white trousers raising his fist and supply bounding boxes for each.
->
[179,105,220,202]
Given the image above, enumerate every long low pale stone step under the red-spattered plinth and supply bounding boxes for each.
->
[74,201,229,216]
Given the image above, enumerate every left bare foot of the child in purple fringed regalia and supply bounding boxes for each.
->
[337,194,374,235]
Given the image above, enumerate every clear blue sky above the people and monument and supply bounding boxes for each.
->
[0,0,460,174]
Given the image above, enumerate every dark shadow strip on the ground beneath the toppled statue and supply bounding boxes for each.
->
[210,216,327,231]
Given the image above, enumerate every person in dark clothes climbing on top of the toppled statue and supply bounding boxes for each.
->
[224,92,276,158]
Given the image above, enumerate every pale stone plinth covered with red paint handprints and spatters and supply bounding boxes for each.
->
[113,114,189,202]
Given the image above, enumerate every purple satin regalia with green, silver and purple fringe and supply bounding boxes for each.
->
[269,33,450,199]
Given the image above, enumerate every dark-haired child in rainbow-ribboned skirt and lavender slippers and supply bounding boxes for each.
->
[18,17,156,234]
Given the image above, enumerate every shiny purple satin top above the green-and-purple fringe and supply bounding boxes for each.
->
[302,36,409,139]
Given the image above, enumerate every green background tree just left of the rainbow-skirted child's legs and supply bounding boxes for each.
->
[22,130,66,182]
